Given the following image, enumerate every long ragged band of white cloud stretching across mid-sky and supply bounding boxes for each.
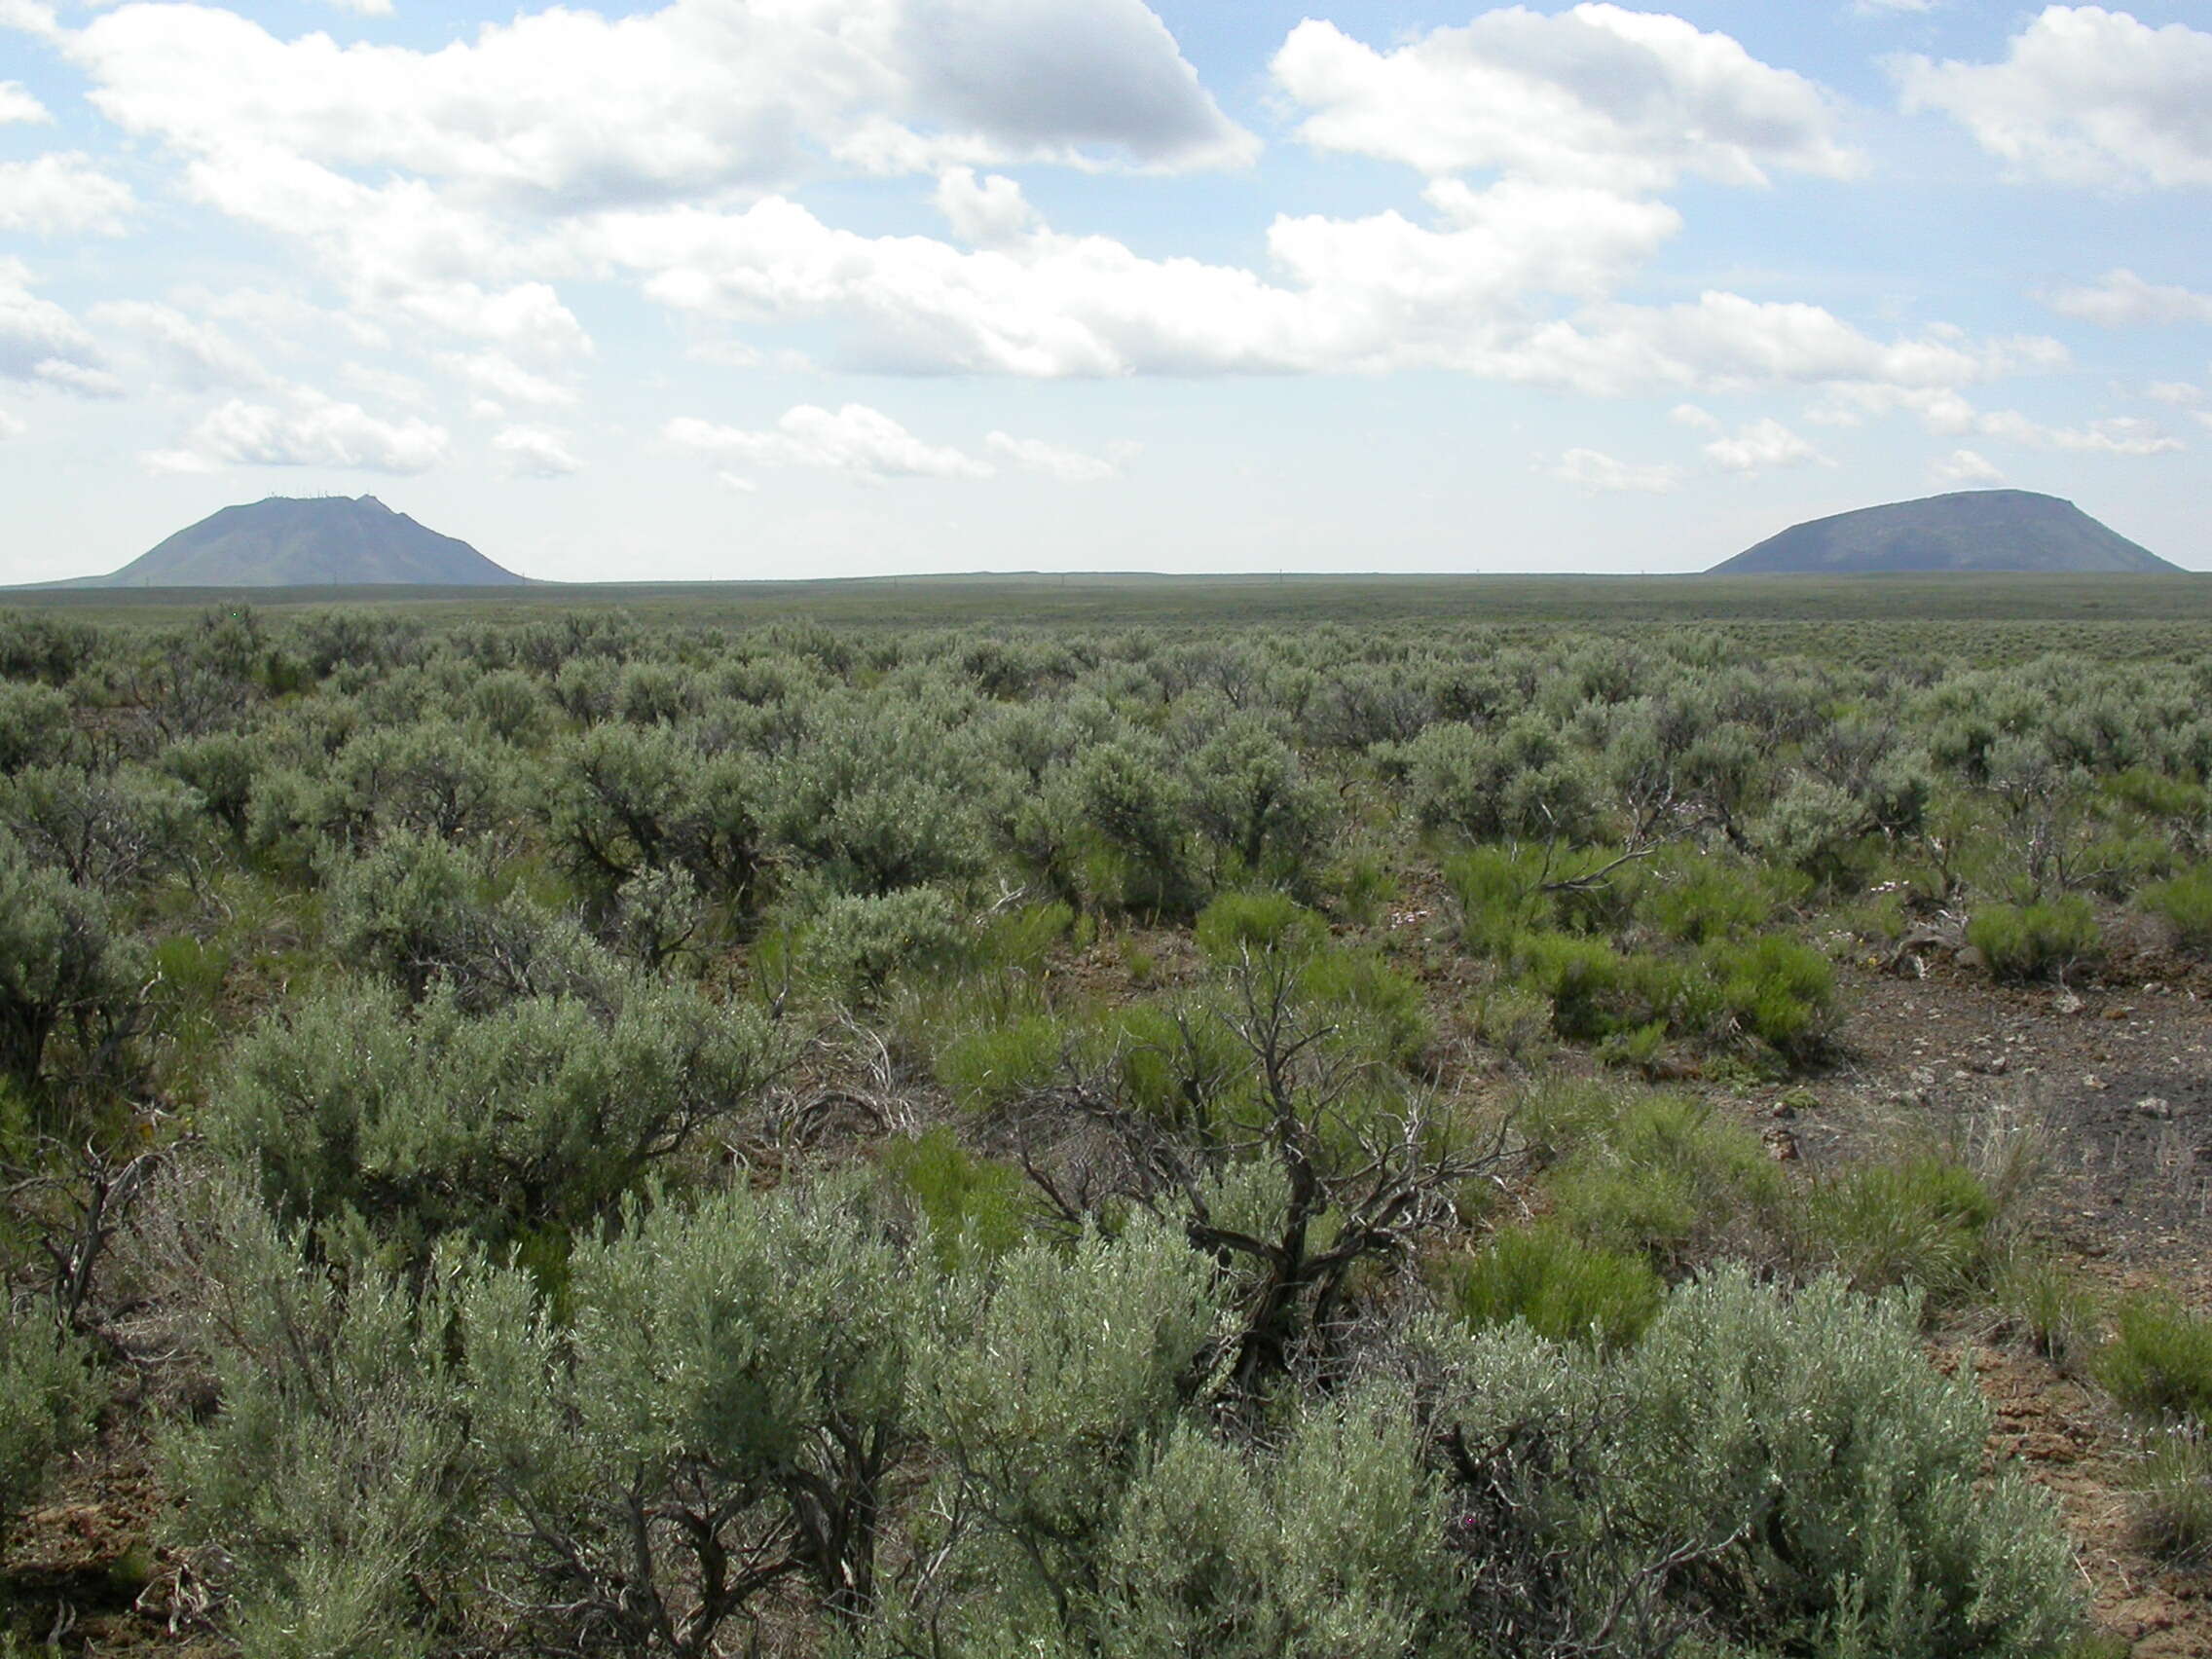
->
[591,190,2026,393]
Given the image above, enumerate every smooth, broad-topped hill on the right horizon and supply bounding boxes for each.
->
[1713,489,2179,575]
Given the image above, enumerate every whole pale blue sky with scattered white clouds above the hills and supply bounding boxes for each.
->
[0,0,2212,582]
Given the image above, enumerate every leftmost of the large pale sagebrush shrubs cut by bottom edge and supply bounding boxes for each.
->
[164,1181,473,1659]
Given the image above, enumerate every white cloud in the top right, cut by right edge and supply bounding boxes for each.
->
[1894,7,2212,188]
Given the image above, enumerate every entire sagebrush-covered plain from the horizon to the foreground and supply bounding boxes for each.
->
[0,577,2212,1659]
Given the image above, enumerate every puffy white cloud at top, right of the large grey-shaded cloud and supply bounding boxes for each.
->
[1272,5,1856,190]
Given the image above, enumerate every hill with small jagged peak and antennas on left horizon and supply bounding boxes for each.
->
[73,496,529,588]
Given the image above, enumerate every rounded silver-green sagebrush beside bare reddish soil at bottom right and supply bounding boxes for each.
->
[1624,1270,2080,1654]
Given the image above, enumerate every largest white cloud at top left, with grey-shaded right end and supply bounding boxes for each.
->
[66,0,1254,208]
